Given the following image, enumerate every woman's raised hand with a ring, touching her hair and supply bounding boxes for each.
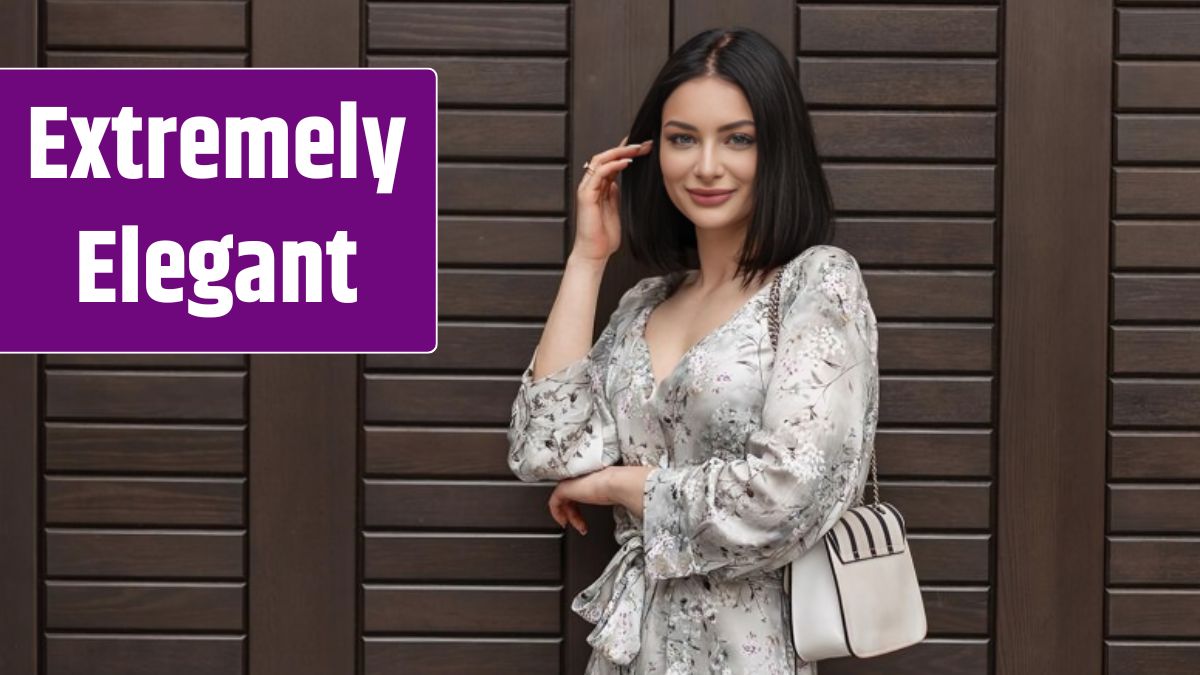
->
[571,136,654,262]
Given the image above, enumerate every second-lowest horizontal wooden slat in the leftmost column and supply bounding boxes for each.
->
[46,581,246,631]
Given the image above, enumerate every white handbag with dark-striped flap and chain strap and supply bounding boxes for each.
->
[769,266,928,663]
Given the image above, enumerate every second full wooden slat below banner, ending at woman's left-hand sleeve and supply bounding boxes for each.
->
[364,426,512,479]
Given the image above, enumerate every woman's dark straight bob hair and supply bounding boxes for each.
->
[619,28,834,286]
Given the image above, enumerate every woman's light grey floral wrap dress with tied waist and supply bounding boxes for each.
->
[508,245,878,675]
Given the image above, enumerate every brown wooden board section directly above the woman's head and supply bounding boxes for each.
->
[671,0,796,60]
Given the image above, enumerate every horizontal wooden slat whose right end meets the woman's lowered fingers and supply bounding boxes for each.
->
[364,479,552,532]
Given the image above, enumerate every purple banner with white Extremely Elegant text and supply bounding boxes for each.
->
[0,68,437,353]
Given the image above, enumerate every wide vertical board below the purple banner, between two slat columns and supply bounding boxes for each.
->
[247,354,359,675]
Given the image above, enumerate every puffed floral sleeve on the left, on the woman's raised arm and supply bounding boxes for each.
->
[508,277,652,483]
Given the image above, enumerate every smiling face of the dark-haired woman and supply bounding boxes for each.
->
[656,77,758,229]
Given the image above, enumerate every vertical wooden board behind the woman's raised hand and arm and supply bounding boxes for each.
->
[571,0,676,675]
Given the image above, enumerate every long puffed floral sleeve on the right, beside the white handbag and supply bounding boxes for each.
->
[643,245,878,579]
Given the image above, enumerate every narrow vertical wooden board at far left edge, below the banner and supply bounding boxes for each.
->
[0,354,40,674]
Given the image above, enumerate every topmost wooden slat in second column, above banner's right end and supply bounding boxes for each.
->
[366,1,568,54]
